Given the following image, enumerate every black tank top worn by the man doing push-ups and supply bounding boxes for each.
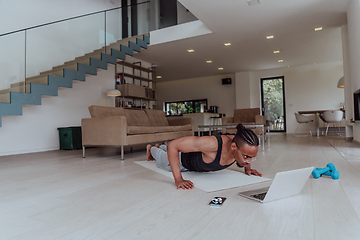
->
[181,135,235,172]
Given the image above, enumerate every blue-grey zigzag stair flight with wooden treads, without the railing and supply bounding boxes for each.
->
[0,34,150,127]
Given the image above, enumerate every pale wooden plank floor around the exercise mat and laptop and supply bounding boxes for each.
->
[0,135,360,240]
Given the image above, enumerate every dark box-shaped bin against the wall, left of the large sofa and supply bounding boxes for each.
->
[58,127,82,150]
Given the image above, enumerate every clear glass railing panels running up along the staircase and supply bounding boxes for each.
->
[0,1,150,99]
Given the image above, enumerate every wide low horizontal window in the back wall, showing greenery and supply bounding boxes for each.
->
[165,99,207,116]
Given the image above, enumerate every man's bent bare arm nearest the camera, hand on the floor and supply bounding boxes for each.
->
[167,136,217,189]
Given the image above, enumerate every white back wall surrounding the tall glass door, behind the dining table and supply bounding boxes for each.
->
[243,61,344,133]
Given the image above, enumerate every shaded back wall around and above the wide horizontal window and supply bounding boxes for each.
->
[156,74,235,116]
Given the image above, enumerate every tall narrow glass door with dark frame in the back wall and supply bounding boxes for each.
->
[261,76,286,132]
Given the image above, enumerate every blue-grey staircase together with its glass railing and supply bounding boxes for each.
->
[0,2,150,126]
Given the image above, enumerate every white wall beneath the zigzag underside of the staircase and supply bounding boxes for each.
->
[0,64,115,155]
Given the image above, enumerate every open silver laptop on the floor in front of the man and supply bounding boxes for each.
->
[239,167,314,203]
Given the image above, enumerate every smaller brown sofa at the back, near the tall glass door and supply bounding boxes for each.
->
[221,108,266,135]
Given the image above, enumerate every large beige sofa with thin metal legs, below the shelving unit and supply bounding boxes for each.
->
[81,105,194,160]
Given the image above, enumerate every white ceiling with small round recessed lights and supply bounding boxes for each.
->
[137,0,350,81]
